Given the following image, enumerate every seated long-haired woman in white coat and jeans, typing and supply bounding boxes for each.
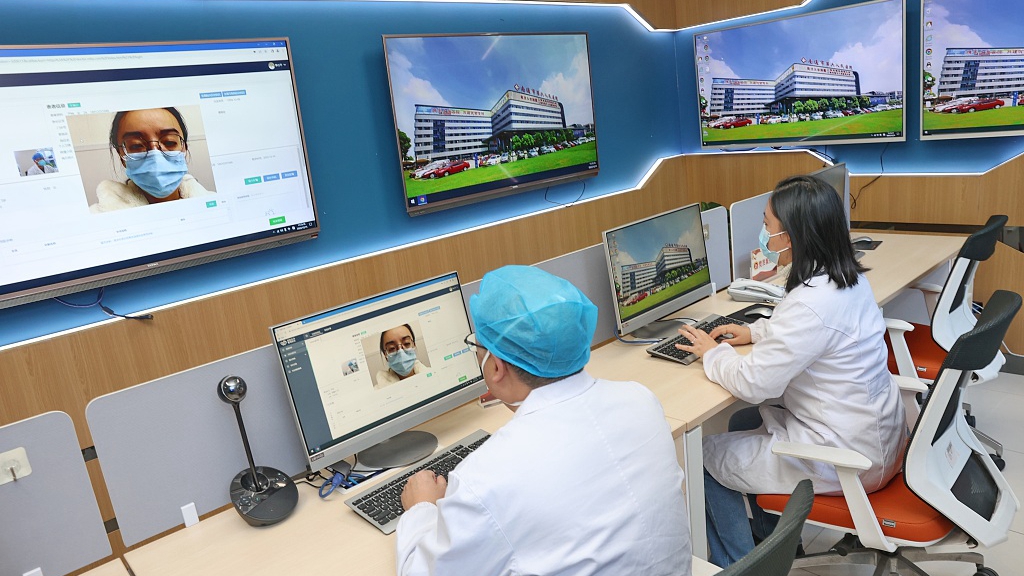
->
[679,176,906,567]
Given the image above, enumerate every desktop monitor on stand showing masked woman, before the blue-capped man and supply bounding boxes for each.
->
[270,273,484,469]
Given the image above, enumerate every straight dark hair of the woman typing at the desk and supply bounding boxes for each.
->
[768,172,867,291]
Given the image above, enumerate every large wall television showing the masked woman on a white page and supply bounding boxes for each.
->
[0,38,318,307]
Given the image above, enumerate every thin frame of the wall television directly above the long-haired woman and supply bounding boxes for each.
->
[690,0,909,150]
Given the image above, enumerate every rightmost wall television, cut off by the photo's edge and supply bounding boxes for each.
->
[921,0,1024,139]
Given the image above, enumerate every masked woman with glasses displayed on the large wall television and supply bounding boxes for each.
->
[89,108,213,212]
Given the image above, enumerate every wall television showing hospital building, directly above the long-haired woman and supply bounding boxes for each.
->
[693,0,906,149]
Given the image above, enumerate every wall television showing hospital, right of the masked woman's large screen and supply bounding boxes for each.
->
[384,33,598,215]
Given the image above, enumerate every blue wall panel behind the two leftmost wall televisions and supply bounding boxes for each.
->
[0,0,682,345]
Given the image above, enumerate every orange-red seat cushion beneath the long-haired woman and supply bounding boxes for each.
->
[758,472,953,543]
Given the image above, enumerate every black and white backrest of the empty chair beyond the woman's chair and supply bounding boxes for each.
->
[932,214,1009,352]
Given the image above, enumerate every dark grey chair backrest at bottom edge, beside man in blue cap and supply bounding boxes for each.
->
[718,480,814,576]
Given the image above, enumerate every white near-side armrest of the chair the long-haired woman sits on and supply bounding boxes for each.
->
[772,442,896,552]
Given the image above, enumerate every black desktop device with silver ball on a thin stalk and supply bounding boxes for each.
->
[217,376,299,526]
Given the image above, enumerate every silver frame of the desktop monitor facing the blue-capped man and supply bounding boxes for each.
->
[269,271,487,470]
